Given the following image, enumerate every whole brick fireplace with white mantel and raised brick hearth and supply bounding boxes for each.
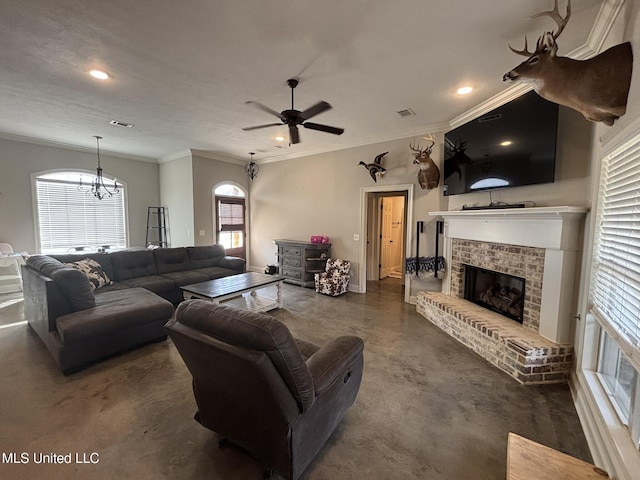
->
[416,207,586,384]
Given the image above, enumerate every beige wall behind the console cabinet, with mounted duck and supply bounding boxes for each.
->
[250,134,442,290]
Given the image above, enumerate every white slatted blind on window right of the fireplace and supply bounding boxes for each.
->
[592,137,640,369]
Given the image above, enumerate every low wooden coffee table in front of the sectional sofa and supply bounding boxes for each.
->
[180,272,284,312]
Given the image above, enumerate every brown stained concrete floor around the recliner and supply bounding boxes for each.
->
[0,279,591,480]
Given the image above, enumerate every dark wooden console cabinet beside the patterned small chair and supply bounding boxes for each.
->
[273,240,331,287]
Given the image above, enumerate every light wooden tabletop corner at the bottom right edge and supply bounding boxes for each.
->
[507,433,610,480]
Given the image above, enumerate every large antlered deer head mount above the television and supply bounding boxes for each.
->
[502,0,633,125]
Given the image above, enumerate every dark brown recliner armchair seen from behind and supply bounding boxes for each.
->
[165,300,364,480]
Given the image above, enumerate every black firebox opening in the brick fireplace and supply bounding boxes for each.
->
[464,265,525,323]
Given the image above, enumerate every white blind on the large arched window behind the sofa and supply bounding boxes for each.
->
[36,174,127,253]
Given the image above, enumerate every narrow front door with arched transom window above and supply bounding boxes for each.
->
[213,183,247,258]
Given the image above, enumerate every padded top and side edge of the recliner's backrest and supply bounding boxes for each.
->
[176,300,315,412]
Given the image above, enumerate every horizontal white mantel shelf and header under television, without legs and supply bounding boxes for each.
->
[429,206,588,250]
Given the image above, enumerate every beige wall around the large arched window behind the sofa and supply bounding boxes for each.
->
[0,139,160,253]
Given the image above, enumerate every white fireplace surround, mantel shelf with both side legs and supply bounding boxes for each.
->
[429,206,588,344]
